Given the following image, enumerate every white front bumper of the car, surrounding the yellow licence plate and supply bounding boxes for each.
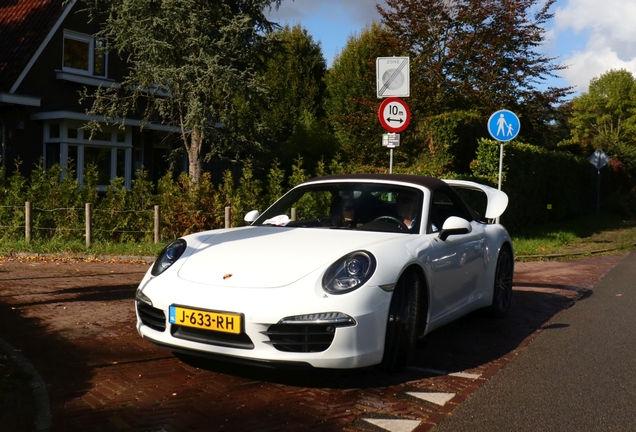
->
[136,287,391,369]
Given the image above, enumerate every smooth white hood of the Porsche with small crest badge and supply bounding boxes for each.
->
[178,227,398,288]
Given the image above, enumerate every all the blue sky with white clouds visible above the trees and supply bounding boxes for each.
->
[270,0,636,93]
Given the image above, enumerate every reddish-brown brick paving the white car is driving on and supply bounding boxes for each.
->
[0,255,623,432]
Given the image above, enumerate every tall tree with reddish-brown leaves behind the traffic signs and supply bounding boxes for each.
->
[378,0,571,143]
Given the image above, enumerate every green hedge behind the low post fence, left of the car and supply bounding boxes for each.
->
[0,157,344,242]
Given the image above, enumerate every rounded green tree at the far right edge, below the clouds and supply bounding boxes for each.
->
[563,69,636,170]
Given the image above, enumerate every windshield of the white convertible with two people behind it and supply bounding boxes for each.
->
[253,182,423,234]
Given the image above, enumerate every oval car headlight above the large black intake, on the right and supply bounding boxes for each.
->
[322,251,376,294]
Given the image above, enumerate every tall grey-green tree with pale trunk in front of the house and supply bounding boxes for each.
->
[79,0,282,183]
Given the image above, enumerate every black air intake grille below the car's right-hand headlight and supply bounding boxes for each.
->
[263,324,336,353]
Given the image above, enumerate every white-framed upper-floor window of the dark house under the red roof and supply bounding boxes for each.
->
[63,31,108,76]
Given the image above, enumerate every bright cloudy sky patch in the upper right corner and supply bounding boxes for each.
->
[550,0,636,91]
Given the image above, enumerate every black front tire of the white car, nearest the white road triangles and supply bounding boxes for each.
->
[380,270,421,372]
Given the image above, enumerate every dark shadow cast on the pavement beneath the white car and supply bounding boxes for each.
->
[169,291,572,389]
